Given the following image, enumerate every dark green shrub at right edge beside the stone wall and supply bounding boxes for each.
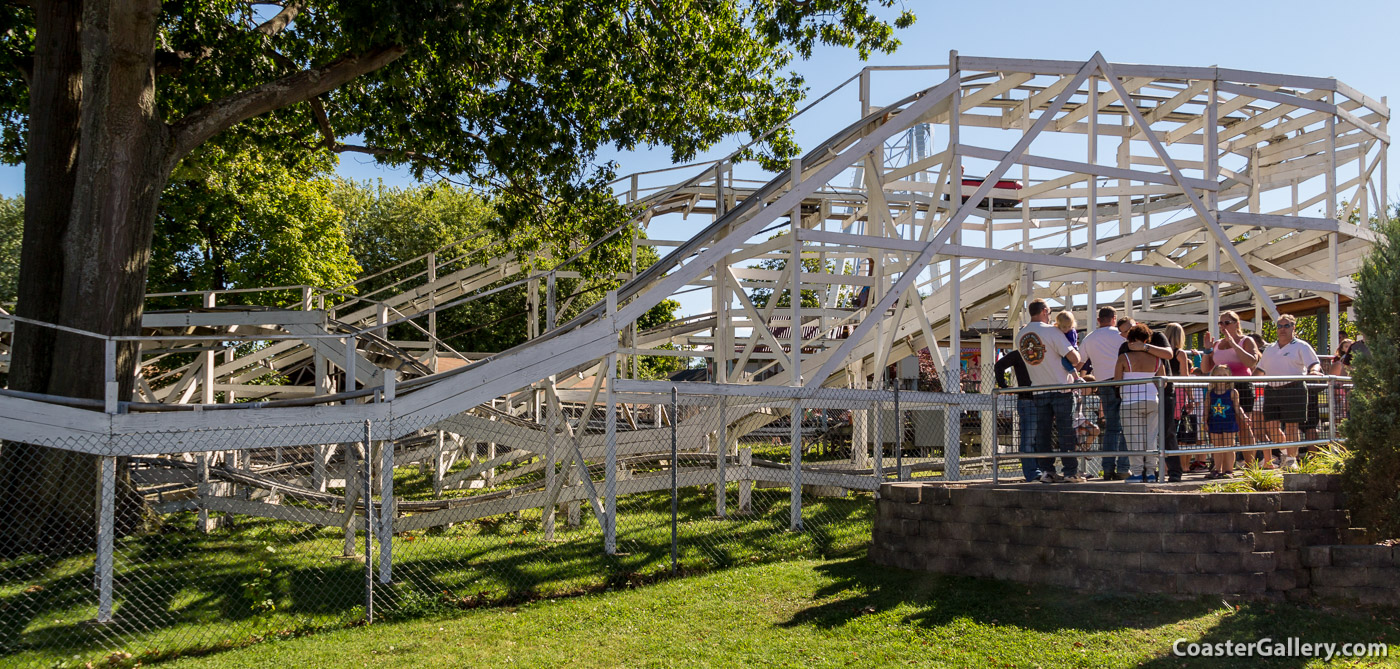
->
[1343,218,1400,537]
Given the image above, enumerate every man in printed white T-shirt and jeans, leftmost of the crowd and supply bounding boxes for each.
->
[1016,300,1084,483]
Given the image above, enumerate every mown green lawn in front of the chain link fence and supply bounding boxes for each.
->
[162,556,1400,668]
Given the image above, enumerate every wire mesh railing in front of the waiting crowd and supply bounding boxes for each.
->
[994,375,1351,483]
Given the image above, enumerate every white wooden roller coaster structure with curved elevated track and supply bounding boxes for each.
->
[0,53,1389,559]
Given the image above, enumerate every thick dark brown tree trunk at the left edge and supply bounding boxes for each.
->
[0,0,171,554]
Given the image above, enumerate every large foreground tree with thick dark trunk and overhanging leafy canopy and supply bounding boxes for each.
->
[0,0,913,550]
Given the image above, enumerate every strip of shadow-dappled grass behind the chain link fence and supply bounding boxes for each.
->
[0,487,872,665]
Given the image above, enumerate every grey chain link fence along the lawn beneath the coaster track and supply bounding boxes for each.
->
[0,382,991,666]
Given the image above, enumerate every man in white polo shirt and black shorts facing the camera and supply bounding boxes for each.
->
[1254,314,1322,469]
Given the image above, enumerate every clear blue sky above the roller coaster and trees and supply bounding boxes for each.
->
[0,0,1400,197]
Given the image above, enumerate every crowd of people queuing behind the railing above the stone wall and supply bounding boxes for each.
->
[994,300,1365,483]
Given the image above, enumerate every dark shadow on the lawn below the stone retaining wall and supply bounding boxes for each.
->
[781,557,1400,668]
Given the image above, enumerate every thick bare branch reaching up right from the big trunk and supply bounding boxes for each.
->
[167,45,407,162]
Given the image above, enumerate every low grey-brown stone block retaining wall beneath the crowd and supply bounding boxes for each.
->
[871,474,1400,603]
